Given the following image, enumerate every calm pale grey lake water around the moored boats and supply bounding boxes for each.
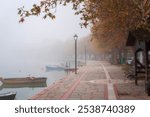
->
[0,57,84,100]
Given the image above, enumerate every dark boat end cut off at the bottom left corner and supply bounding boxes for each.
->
[0,91,16,100]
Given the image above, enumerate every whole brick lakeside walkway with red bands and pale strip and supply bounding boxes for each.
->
[30,61,150,100]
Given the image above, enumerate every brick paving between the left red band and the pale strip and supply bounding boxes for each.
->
[68,62,106,100]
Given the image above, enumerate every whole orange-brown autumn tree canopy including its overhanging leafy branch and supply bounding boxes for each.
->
[18,0,150,50]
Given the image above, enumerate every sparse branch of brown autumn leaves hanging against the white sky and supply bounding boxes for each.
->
[18,0,88,23]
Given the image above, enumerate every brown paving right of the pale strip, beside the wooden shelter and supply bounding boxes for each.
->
[105,63,150,100]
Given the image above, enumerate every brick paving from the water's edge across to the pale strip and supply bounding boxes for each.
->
[30,61,107,100]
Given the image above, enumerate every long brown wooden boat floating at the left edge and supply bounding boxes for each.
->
[0,77,47,84]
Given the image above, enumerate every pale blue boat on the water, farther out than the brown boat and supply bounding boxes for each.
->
[45,65,64,72]
